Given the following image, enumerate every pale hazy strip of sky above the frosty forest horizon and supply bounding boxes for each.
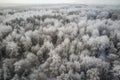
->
[0,0,120,7]
